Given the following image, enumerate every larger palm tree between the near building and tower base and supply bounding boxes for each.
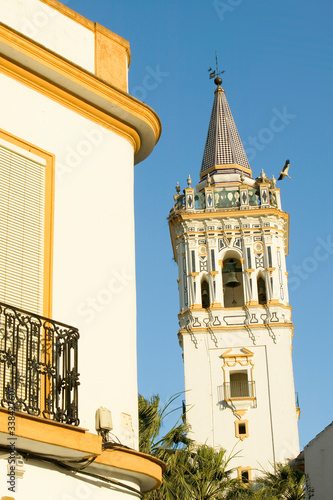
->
[139,394,240,500]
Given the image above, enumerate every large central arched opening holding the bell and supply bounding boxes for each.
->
[222,255,245,307]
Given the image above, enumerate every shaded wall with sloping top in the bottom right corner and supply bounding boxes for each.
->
[304,422,333,500]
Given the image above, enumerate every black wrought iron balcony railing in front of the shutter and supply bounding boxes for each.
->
[0,302,79,425]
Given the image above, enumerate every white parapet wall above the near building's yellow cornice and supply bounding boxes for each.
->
[0,0,95,73]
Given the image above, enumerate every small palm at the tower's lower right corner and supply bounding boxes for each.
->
[256,463,305,500]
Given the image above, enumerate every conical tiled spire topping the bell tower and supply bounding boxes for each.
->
[201,83,251,178]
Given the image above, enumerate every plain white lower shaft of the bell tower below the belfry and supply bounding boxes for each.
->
[184,329,299,477]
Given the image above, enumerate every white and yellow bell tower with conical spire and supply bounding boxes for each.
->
[169,77,299,481]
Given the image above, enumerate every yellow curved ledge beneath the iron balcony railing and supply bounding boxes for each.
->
[0,408,165,492]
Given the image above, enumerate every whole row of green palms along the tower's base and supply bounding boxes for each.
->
[139,394,305,500]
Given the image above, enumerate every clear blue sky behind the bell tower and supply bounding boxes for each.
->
[67,0,333,448]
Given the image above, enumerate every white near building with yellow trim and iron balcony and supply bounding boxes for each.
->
[0,0,161,500]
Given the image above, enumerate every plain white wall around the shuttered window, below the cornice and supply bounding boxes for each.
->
[0,69,137,447]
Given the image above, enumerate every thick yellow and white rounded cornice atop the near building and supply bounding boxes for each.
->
[0,25,161,161]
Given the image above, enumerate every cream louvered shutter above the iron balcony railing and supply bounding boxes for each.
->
[0,144,46,314]
